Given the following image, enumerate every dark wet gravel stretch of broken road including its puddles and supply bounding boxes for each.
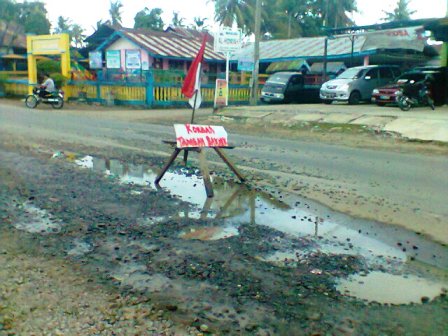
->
[0,154,448,335]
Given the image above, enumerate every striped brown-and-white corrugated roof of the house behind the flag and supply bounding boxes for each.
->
[119,29,225,61]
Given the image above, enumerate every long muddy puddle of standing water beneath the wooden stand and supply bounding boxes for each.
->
[70,156,448,304]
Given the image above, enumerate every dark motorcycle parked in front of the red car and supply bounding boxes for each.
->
[397,82,435,111]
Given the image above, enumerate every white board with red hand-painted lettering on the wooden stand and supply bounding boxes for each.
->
[174,124,228,148]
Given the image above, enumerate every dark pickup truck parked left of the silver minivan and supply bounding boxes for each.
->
[260,72,320,103]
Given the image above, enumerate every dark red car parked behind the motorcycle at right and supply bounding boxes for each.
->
[372,67,445,106]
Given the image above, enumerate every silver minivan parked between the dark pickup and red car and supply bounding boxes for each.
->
[320,65,400,105]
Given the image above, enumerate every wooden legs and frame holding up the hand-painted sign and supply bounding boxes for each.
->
[154,140,246,197]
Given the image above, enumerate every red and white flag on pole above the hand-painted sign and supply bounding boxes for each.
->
[182,35,207,109]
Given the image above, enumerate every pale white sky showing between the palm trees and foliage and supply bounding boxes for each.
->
[18,0,448,35]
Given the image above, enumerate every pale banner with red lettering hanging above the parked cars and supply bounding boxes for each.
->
[355,27,425,51]
